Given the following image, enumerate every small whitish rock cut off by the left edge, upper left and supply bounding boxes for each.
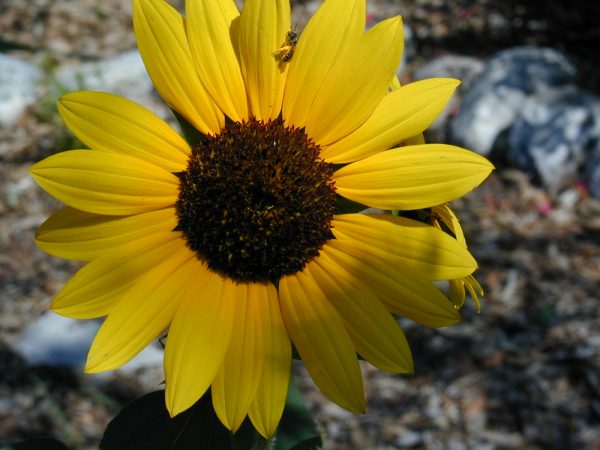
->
[0,54,42,128]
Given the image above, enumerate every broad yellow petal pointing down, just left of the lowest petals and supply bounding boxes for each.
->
[165,269,237,417]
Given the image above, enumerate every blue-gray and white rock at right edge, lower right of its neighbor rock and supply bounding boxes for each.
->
[507,87,600,193]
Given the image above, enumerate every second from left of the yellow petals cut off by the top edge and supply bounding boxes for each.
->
[185,0,248,122]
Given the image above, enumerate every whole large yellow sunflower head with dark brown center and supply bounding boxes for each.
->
[31,0,492,437]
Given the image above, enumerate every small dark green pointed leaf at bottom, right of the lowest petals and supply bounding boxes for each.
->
[273,380,323,450]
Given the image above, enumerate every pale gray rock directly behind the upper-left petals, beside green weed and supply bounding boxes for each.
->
[56,50,166,111]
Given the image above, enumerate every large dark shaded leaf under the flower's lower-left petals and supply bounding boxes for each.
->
[100,391,232,450]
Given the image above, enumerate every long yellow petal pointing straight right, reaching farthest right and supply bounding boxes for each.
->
[334,144,494,210]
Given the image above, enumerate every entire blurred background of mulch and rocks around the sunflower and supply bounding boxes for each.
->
[0,0,600,450]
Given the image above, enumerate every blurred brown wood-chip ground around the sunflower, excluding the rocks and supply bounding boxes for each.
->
[0,0,600,450]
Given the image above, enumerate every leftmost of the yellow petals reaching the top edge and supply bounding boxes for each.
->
[133,0,225,134]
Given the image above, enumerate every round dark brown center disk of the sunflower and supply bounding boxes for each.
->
[176,119,336,283]
